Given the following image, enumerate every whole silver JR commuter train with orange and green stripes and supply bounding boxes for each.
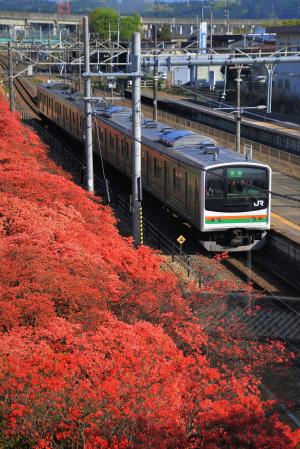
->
[38,84,271,251]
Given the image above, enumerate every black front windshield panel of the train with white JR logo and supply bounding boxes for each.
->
[205,166,269,212]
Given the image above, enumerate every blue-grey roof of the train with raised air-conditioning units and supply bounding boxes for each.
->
[39,83,265,170]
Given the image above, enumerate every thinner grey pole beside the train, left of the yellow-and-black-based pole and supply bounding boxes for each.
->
[83,16,94,192]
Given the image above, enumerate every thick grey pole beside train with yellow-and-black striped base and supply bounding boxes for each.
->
[131,33,143,246]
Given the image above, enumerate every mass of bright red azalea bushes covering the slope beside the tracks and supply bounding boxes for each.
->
[0,93,300,449]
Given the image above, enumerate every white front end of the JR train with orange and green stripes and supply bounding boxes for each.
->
[201,161,271,251]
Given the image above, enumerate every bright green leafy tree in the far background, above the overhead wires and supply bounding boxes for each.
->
[90,8,141,41]
